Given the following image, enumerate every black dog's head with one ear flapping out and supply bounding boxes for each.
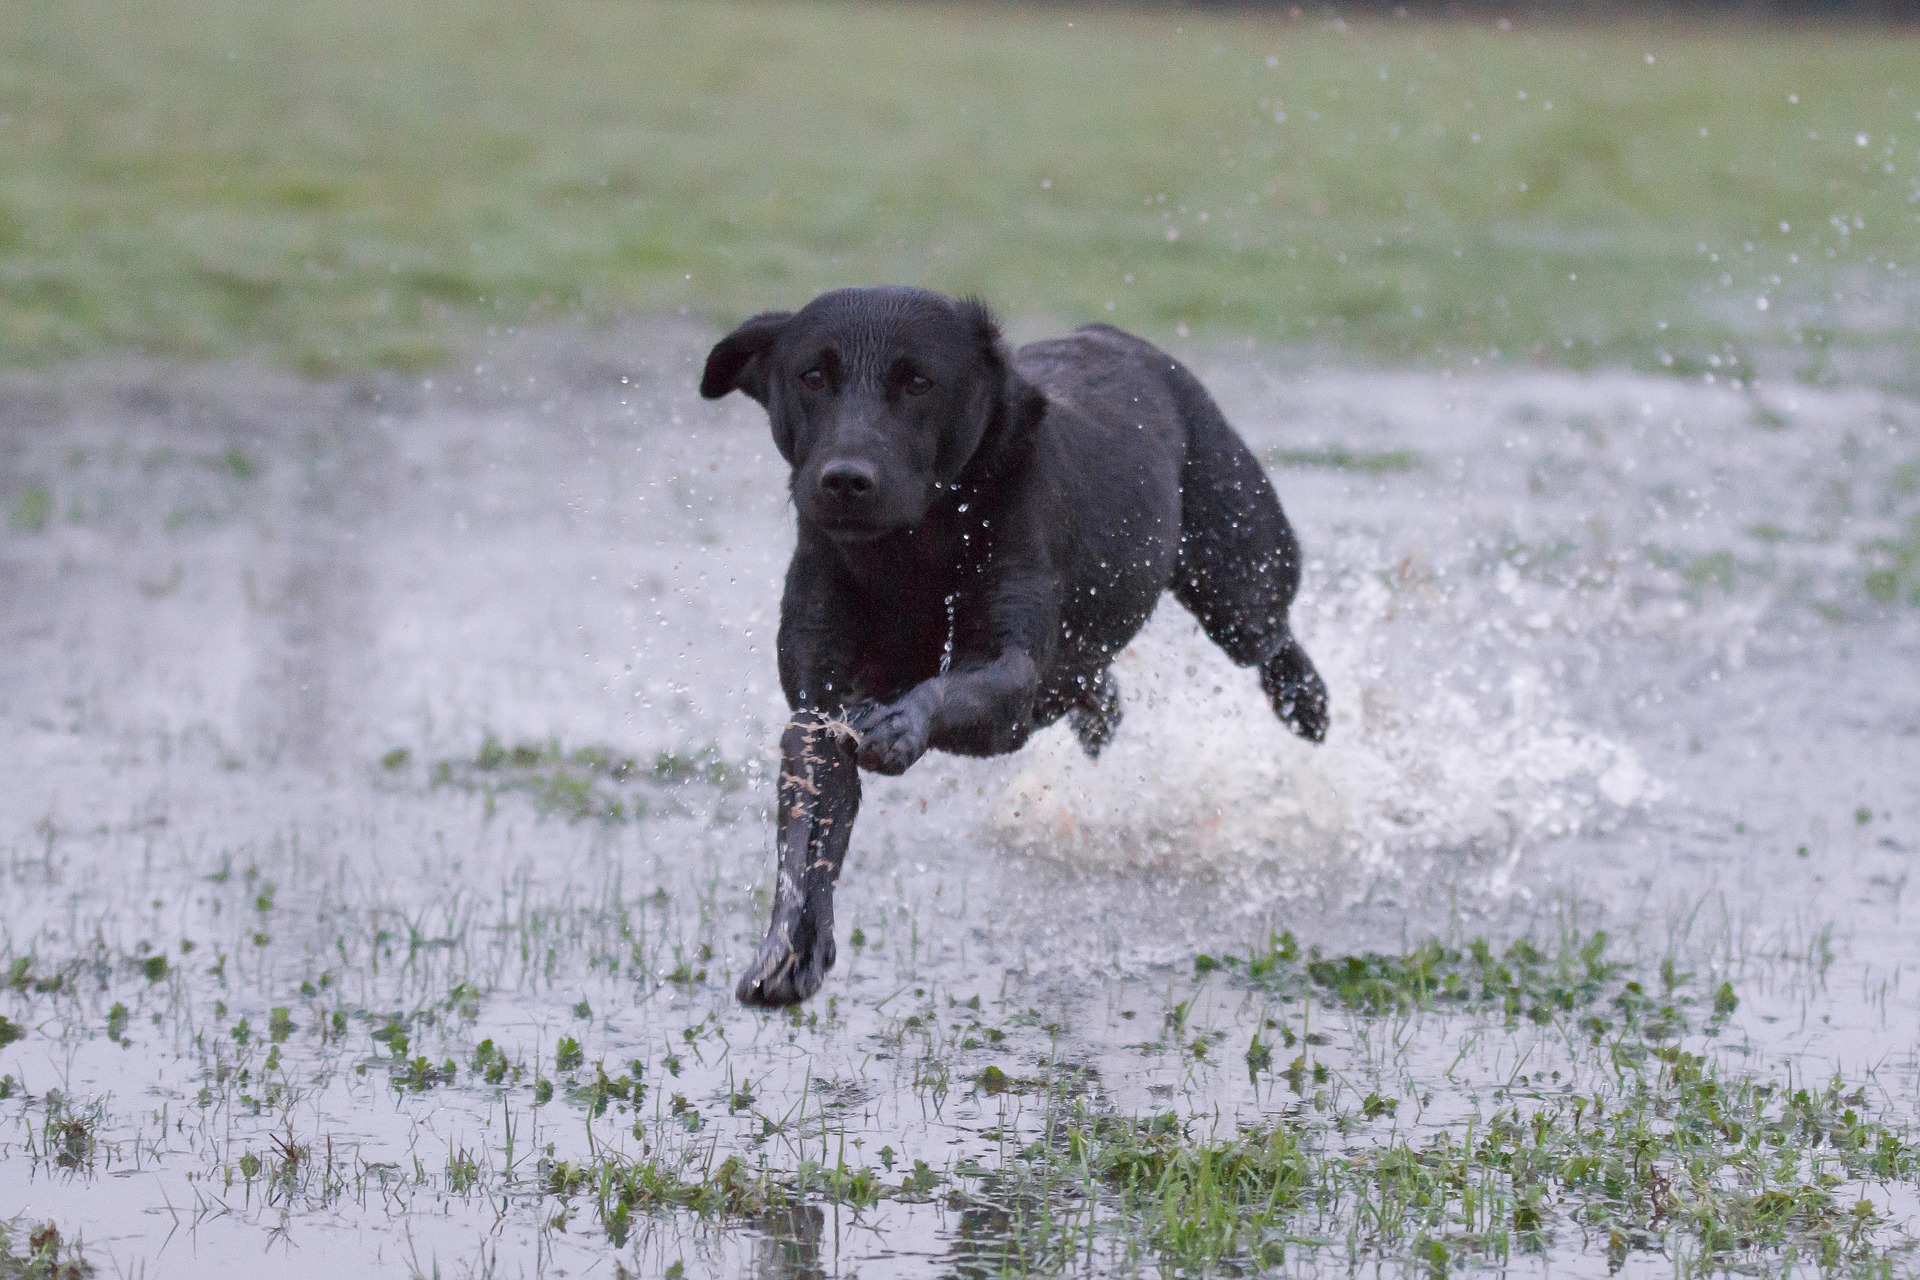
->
[701,288,1046,541]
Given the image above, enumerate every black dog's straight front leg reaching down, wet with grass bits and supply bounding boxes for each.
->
[735,710,860,1009]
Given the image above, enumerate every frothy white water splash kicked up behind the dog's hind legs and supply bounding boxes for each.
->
[993,560,1659,879]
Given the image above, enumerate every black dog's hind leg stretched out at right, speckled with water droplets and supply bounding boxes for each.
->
[1171,367,1327,743]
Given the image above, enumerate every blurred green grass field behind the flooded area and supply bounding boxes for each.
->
[0,0,1920,378]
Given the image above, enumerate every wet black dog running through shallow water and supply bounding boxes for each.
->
[701,288,1327,1006]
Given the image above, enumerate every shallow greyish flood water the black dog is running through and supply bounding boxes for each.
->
[0,324,1920,1276]
